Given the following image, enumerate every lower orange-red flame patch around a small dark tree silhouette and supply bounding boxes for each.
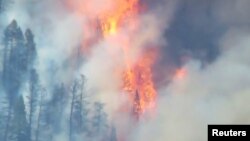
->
[123,52,156,116]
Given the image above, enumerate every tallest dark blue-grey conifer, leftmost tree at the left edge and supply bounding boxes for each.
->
[2,20,25,141]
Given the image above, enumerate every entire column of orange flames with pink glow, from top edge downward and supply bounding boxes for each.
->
[66,0,157,117]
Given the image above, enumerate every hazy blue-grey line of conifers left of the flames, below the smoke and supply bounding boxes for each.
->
[0,20,116,141]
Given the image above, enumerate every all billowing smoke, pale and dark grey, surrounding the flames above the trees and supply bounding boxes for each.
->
[0,0,250,141]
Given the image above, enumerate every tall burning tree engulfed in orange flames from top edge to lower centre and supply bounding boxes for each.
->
[69,0,157,119]
